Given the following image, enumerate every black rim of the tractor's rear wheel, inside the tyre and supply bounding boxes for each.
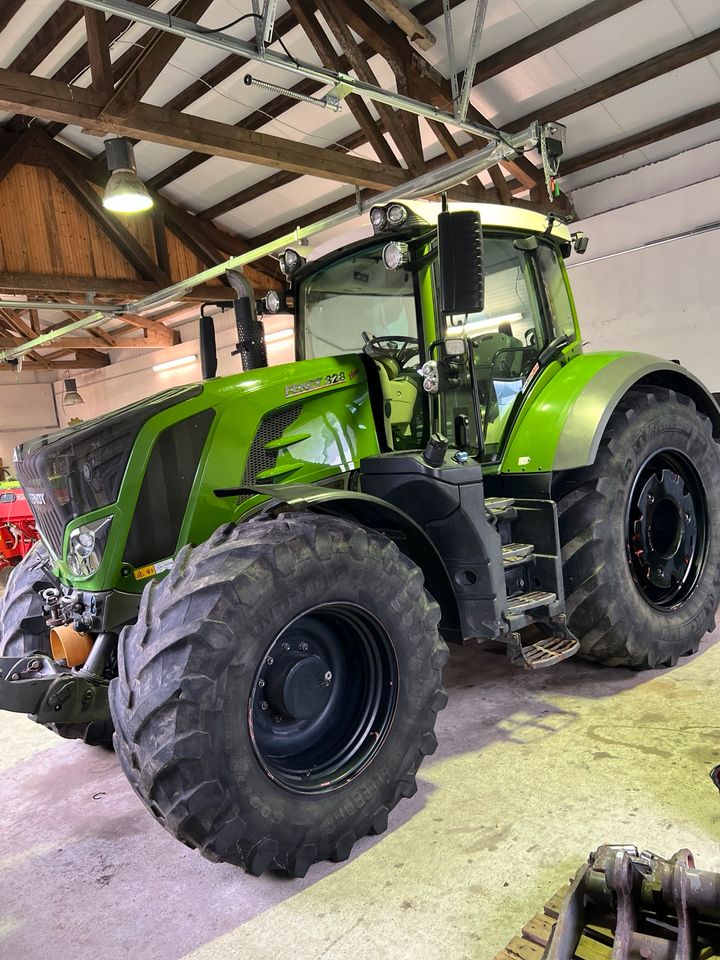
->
[626,450,708,610]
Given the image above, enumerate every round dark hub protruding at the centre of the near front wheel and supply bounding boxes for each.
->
[265,650,332,720]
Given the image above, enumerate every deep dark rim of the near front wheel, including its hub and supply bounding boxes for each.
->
[249,604,398,793]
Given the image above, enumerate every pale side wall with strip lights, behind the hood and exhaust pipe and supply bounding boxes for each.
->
[55,312,295,426]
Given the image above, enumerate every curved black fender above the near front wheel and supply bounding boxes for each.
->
[238,483,460,640]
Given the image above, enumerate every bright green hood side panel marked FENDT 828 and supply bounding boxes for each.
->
[54,355,379,593]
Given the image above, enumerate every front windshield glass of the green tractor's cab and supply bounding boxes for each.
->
[300,243,418,360]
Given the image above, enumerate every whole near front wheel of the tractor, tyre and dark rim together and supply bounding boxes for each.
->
[110,514,447,877]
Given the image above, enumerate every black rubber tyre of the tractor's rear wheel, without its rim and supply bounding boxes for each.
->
[557,387,720,668]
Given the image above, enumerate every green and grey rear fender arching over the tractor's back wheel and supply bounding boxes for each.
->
[500,353,720,473]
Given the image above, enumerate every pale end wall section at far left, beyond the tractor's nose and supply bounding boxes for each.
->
[0,372,58,470]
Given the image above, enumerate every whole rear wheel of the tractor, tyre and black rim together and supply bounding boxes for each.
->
[557,387,720,668]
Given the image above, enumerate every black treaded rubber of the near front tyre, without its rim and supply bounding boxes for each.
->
[110,514,447,876]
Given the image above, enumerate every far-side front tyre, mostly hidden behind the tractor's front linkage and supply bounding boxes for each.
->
[0,541,113,748]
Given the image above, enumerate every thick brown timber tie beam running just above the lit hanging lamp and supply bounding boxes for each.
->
[0,69,405,189]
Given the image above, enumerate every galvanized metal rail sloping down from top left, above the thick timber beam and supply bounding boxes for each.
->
[70,0,504,143]
